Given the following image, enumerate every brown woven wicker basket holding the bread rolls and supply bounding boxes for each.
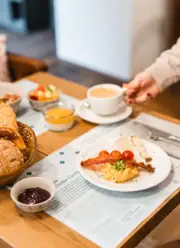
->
[0,122,36,186]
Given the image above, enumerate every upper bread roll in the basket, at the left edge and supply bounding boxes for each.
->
[0,103,18,137]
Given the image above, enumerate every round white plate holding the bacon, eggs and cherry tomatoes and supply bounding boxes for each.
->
[77,139,171,192]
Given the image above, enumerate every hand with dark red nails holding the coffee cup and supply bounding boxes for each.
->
[123,72,160,104]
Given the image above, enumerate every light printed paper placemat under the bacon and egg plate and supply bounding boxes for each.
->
[15,115,180,248]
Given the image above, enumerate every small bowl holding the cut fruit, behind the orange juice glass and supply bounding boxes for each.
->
[28,90,62,112]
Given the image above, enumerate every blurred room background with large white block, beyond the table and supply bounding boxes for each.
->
[0,0,180,86]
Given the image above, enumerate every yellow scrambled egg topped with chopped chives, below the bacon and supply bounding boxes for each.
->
[102,163,139,183]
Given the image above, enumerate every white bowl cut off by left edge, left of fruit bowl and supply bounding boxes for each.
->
[0,82,23,113]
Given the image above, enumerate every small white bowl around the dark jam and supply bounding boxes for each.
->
[11,177,56,213]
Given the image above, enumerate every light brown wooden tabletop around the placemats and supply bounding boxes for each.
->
[0,73,180,248]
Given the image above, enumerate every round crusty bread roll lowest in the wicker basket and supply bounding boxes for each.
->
[0,139,25,179]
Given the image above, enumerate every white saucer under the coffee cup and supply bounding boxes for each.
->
[76,99,132,125]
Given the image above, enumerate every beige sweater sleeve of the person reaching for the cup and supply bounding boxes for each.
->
[146,38,180,90]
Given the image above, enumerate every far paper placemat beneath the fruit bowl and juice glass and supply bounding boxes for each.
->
[17,79,79,136]
